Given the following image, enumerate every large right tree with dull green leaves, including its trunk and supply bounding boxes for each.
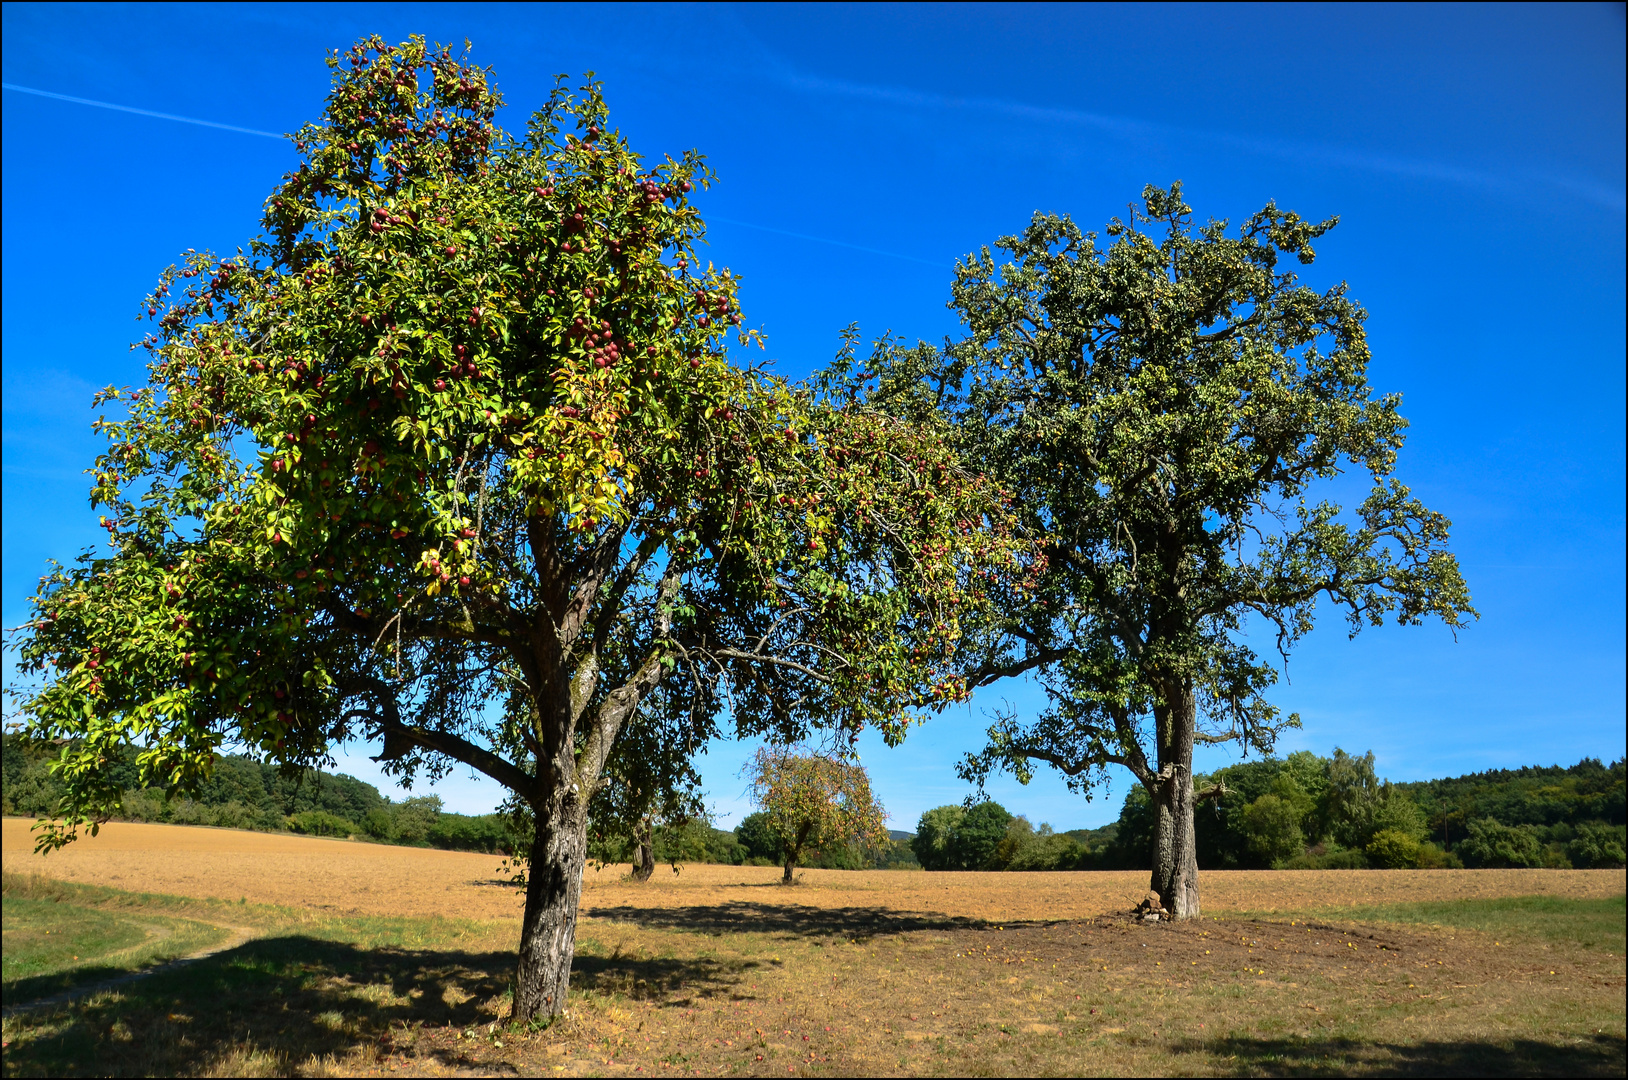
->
[860,184,1473,915]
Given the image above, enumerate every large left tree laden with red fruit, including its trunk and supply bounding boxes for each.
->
[15,37,1019,1020]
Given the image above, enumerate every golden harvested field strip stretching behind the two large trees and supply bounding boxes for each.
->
[3,818,1625,929]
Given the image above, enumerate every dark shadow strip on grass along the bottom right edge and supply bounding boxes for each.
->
[1171,1034,1628,1077]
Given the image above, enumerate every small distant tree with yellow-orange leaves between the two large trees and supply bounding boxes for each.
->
[751,748,887,885]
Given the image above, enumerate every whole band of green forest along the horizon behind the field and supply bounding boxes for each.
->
[3,735,1628,870]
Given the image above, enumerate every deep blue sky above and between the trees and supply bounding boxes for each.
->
[0,3,1625,828]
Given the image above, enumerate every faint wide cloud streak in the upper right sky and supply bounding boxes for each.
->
[777,70,1628,212]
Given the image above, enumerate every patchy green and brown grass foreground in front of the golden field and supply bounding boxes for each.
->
[5,878,1625,1077]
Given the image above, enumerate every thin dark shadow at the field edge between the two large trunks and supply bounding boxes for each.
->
[583,901,989,938]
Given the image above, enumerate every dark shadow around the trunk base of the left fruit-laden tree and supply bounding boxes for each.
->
[5,935,744,1077]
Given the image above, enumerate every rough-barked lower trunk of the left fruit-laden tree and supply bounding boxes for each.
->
[513,788,588,1020]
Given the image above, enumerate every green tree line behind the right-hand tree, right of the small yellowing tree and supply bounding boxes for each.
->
[912,749,1628,870]
